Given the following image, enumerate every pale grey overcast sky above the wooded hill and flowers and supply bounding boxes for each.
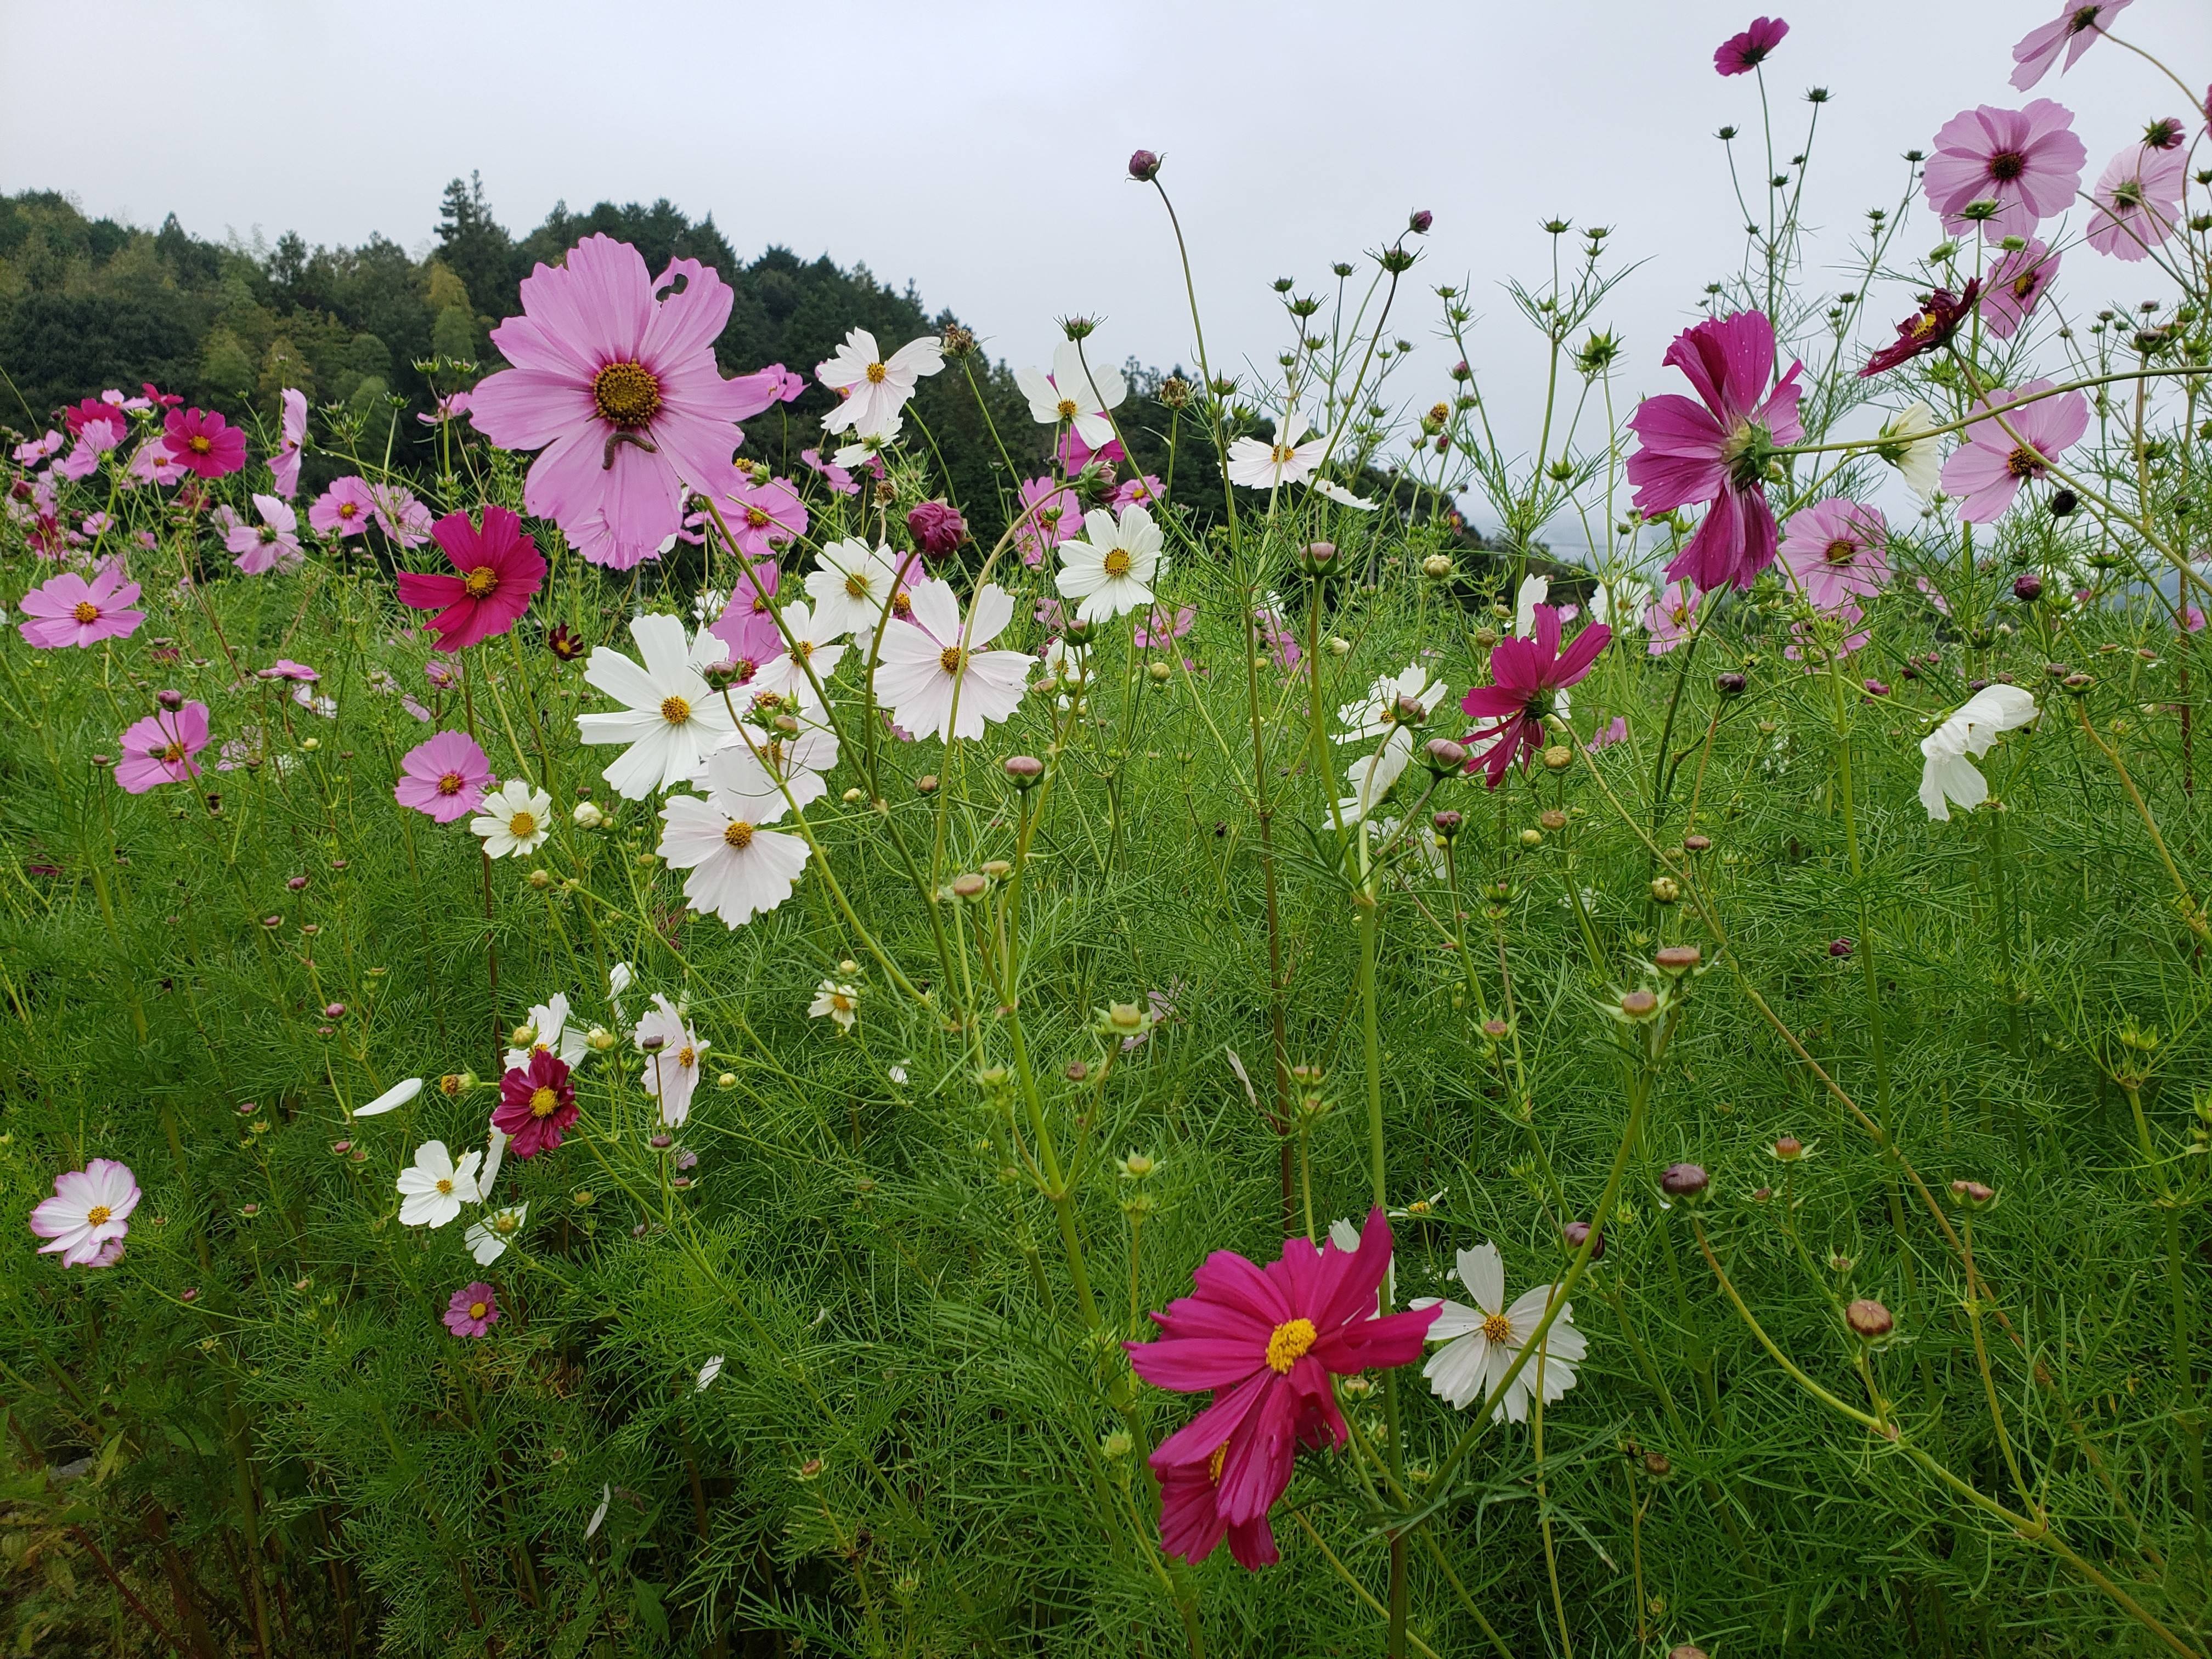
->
[0,0,2212,539]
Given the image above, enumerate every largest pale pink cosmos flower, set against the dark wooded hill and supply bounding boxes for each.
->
[469,234,783,571]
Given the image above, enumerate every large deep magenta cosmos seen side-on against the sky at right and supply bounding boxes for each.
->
[1628,312,1805,589]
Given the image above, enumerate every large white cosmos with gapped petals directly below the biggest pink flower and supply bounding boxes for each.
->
[575,617,732,801]
